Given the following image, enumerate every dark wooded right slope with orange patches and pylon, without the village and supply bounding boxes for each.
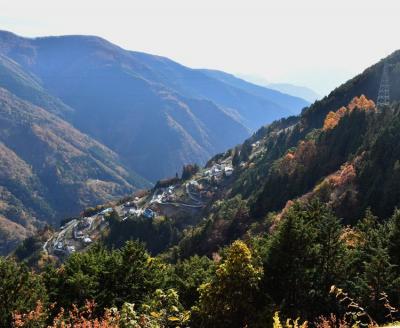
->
[173,52,400,255]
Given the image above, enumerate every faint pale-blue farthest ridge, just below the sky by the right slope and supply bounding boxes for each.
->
[239,74,321,103]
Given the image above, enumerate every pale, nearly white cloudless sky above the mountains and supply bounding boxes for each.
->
[0,0,400,95]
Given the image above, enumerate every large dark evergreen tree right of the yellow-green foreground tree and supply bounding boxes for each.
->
[263,200,346,317]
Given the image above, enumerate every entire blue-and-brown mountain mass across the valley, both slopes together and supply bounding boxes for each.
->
[0,31,309,252]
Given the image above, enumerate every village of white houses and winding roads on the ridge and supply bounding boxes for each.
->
[43,155,239,260]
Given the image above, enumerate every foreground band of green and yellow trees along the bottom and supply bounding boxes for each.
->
[0,199,400,328]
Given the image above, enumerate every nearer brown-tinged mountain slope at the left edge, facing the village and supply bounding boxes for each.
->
[0,88,146,253]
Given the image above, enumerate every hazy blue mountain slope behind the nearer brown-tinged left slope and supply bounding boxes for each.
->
[0,32,308,181]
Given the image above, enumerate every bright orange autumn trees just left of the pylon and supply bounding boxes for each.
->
[322,95,376,131]
